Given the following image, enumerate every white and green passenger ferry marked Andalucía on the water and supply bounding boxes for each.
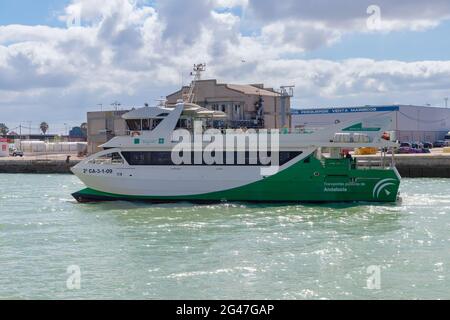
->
[72,100,401,202]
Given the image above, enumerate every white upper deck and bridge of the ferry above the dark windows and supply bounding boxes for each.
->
[102,101,398,149]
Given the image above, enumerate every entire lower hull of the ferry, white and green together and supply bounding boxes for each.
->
[73,155,400,202]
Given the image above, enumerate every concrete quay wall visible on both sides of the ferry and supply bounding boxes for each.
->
[0,151,450,178]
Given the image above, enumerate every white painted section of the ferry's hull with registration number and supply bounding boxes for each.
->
[72,149,313,197]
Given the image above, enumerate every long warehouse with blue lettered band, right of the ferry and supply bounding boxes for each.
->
[291,105,450,142]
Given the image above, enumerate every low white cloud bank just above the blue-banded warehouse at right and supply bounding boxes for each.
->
[239,59,450,106]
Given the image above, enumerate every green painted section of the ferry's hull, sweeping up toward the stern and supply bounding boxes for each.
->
[74,157,400,202]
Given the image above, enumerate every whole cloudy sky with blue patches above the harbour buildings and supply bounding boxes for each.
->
[0,0,450,133]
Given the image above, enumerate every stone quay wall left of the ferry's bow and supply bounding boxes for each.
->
[0,159,80,174]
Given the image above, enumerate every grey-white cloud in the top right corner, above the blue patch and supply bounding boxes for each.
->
[246,0,450,50]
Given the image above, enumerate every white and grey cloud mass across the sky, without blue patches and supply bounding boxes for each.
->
[0,0,450,126]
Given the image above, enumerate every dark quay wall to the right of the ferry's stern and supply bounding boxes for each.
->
[356,154,450,178]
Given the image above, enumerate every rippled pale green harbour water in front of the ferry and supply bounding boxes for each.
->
[0,175,450,299]
